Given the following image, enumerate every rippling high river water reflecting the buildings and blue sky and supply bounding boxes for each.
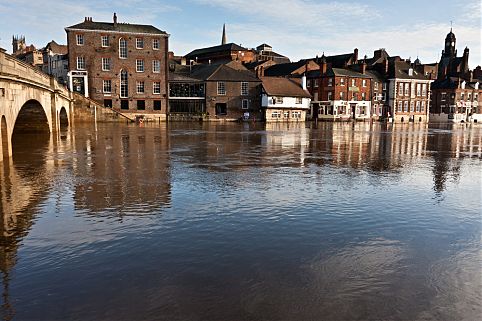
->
[0,123,482,321]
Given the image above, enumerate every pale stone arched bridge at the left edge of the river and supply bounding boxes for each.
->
[0,48,74,162]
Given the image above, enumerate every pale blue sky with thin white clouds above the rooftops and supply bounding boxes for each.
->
[0,0,482,69]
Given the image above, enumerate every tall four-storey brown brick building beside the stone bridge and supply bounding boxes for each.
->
[65,14,169,119]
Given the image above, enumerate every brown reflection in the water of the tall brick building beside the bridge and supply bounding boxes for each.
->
[73,123,171,217]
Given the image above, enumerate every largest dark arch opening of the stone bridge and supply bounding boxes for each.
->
[12,99,50,138]
